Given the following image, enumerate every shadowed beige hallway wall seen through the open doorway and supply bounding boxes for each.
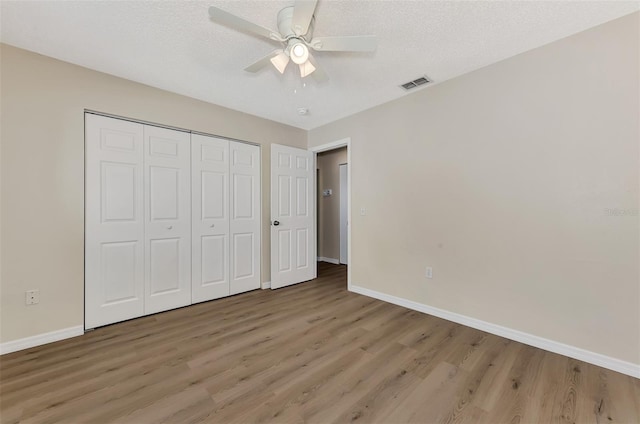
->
[317,147,347,260]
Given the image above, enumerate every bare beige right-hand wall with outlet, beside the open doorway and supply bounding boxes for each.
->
[309,13,640,364]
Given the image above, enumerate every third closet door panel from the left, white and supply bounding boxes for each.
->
[191,134,230,303]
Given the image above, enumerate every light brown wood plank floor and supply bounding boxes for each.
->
[0,264,640,424]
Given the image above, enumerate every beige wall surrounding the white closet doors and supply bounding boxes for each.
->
[0,45,307,342]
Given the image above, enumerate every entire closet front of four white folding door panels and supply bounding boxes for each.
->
[85,113,260,329]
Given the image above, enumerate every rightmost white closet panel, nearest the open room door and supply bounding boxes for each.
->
[229,141,260,294]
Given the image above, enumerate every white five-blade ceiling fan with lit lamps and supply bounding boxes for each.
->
[209,0,378,82]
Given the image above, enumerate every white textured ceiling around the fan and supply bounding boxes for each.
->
[0,0,640,129]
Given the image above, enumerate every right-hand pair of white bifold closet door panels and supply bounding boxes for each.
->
[191,134,260,303]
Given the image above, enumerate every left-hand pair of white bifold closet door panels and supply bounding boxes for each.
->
[85,114,191,328]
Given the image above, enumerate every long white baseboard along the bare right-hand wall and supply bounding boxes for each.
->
[349,285,640,378]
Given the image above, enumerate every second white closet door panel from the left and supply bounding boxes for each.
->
[144,125,191,314]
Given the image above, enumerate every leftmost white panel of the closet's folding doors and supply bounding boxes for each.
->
[85,114,144,329]
